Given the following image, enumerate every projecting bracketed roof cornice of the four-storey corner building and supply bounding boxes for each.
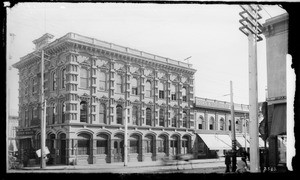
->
[13,33,196,75]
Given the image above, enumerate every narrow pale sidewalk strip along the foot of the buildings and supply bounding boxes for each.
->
[22,157,225,170]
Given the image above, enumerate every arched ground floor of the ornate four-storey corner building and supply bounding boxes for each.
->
[19,127,195,165]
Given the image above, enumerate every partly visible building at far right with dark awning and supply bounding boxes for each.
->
[263,13,288,167]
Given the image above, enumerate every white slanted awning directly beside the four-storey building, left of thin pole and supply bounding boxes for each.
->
[198,134,231,150]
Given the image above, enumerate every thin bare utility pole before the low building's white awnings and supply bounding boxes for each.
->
[230,81,236,172]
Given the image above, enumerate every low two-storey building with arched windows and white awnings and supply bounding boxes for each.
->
[194,97,263,158]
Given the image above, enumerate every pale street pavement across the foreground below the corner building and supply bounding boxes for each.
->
[7,158,225,174]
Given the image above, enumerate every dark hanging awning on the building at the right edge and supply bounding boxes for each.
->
[270,104,286,136]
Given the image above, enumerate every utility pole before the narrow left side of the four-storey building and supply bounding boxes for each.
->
[41,50,46,169]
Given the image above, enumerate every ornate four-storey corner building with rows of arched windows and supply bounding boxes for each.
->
[14,33,196,164]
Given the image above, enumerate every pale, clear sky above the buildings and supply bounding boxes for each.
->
[7,3,286,115]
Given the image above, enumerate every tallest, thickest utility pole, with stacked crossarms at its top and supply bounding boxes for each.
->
[239,5,262,172]
